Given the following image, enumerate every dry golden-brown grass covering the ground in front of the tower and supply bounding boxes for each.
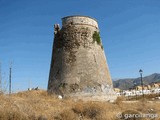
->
[0,90,160,120]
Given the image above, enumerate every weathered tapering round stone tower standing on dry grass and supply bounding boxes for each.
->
[48,16,115,100]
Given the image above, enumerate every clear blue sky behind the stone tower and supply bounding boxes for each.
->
[0,0,160,92]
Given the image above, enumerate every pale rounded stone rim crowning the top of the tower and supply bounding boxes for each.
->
[62,15,98,29]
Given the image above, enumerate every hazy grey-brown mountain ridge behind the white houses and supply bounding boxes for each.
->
[113,73,160,90]
